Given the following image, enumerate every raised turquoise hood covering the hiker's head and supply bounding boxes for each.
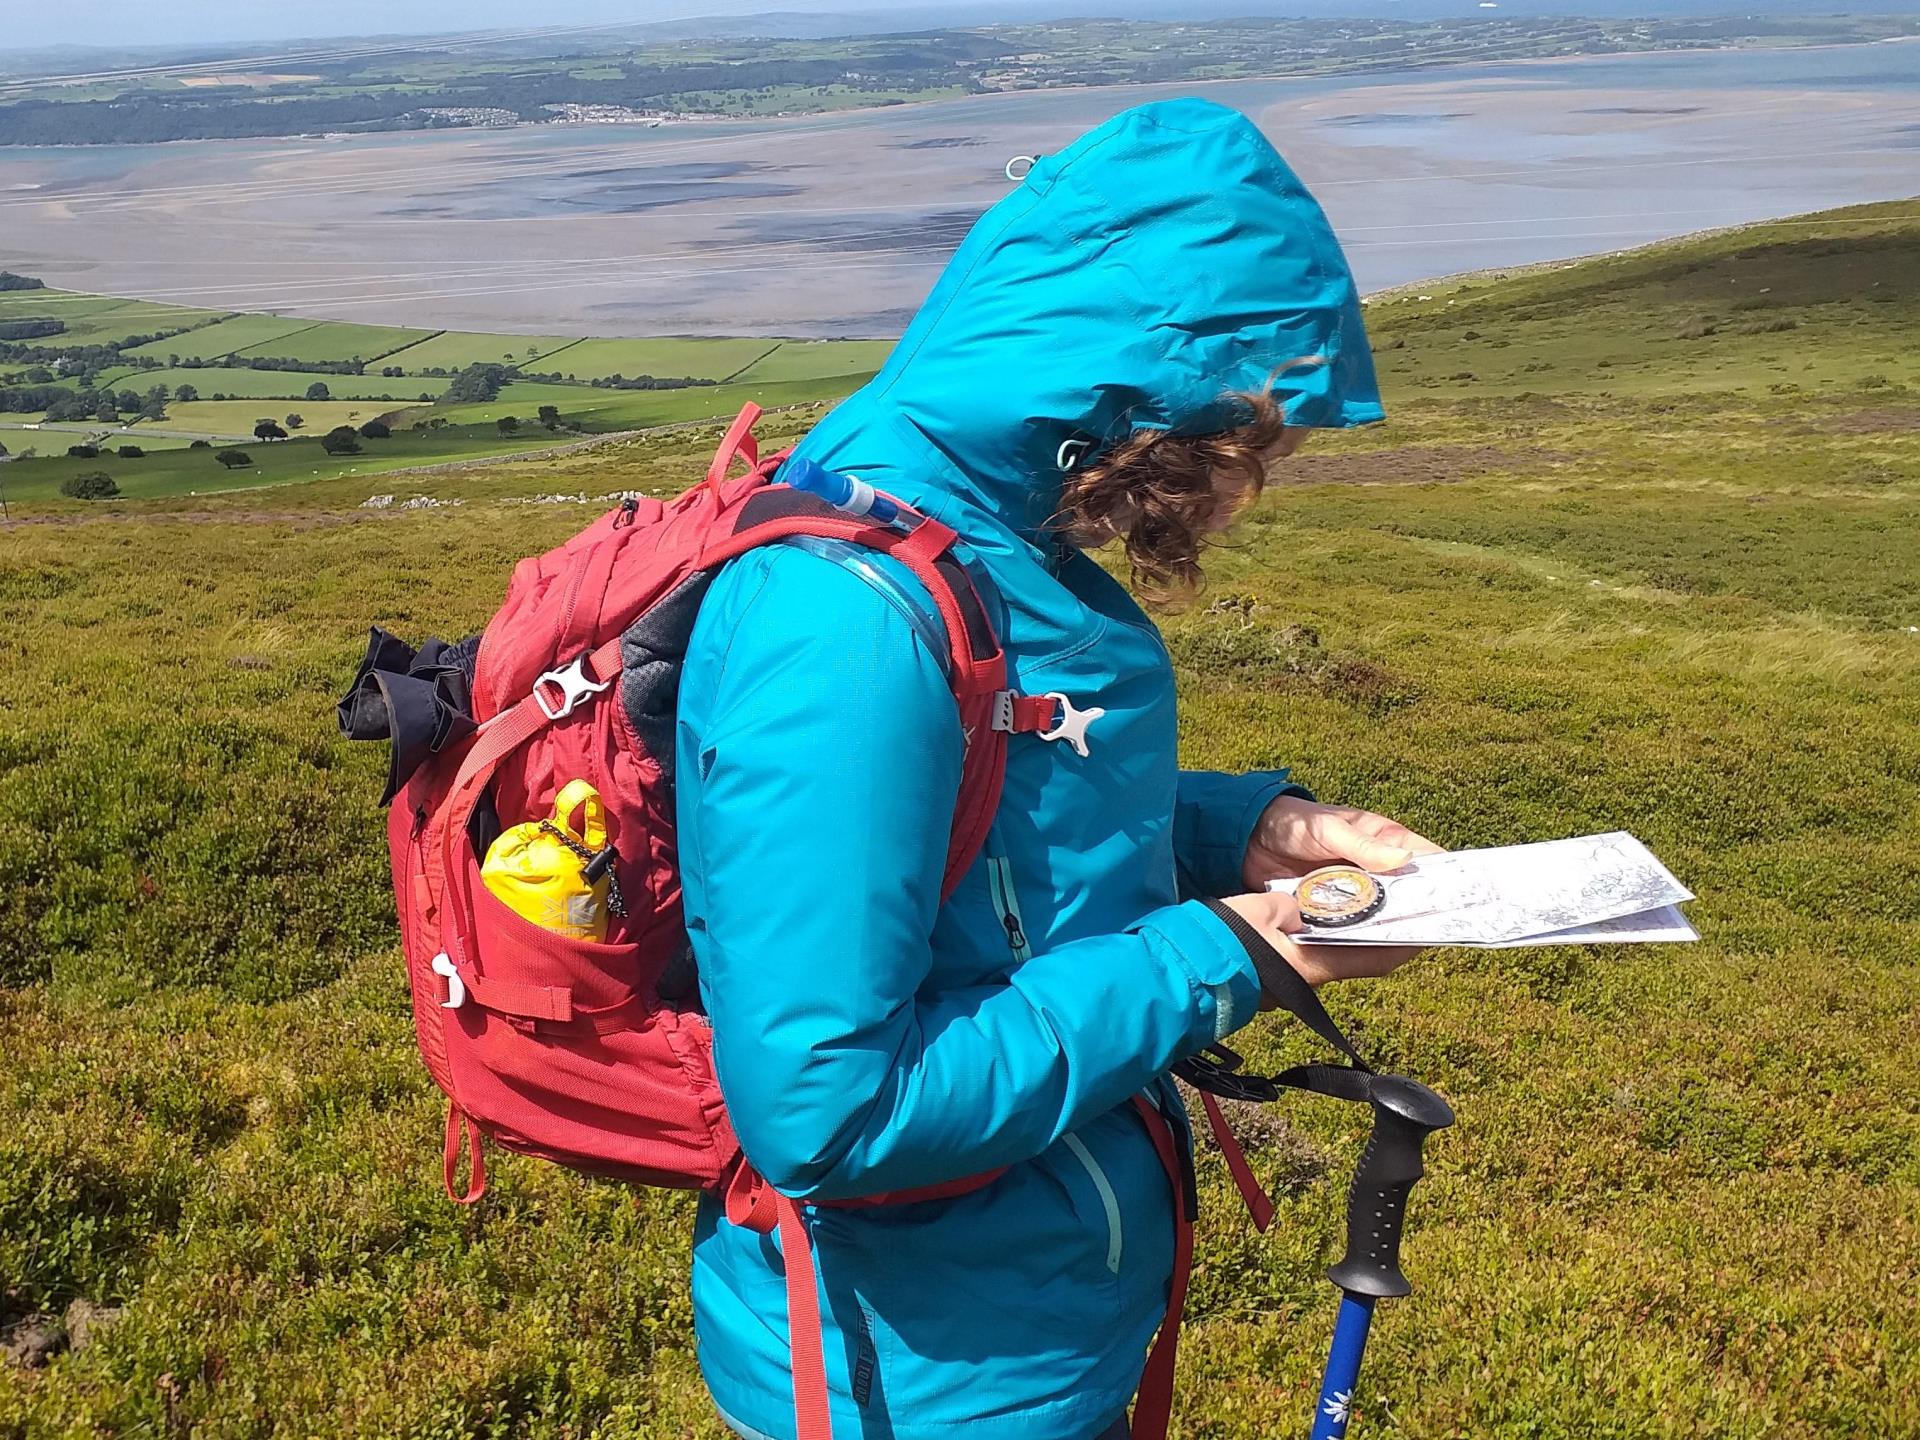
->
[801,100,1384,534]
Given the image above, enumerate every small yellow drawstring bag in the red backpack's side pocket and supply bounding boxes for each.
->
[480,780,624,941]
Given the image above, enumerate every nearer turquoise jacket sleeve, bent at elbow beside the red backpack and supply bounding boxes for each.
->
[678,547,1260,1198]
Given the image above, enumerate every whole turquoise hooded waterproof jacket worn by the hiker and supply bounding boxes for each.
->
[678,100,1380,1440]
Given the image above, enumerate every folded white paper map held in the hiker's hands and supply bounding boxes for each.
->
[1267,829,1699,948]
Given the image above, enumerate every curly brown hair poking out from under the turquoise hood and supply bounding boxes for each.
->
[1052,390,1306,603]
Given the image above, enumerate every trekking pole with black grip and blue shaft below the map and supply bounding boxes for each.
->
[1313,1075,1453,1440]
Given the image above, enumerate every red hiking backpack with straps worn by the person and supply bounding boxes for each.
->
[340,405,1244,1440]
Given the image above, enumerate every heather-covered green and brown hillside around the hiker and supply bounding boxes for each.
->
[0,204,1920,1440]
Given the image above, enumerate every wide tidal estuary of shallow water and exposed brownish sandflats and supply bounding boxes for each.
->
[0,44,1920,334]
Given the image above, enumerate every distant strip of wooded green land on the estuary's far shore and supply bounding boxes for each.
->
[0,4,1920,146]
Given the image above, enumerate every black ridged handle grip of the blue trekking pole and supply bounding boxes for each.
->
[1327,1075,1453,1298]
